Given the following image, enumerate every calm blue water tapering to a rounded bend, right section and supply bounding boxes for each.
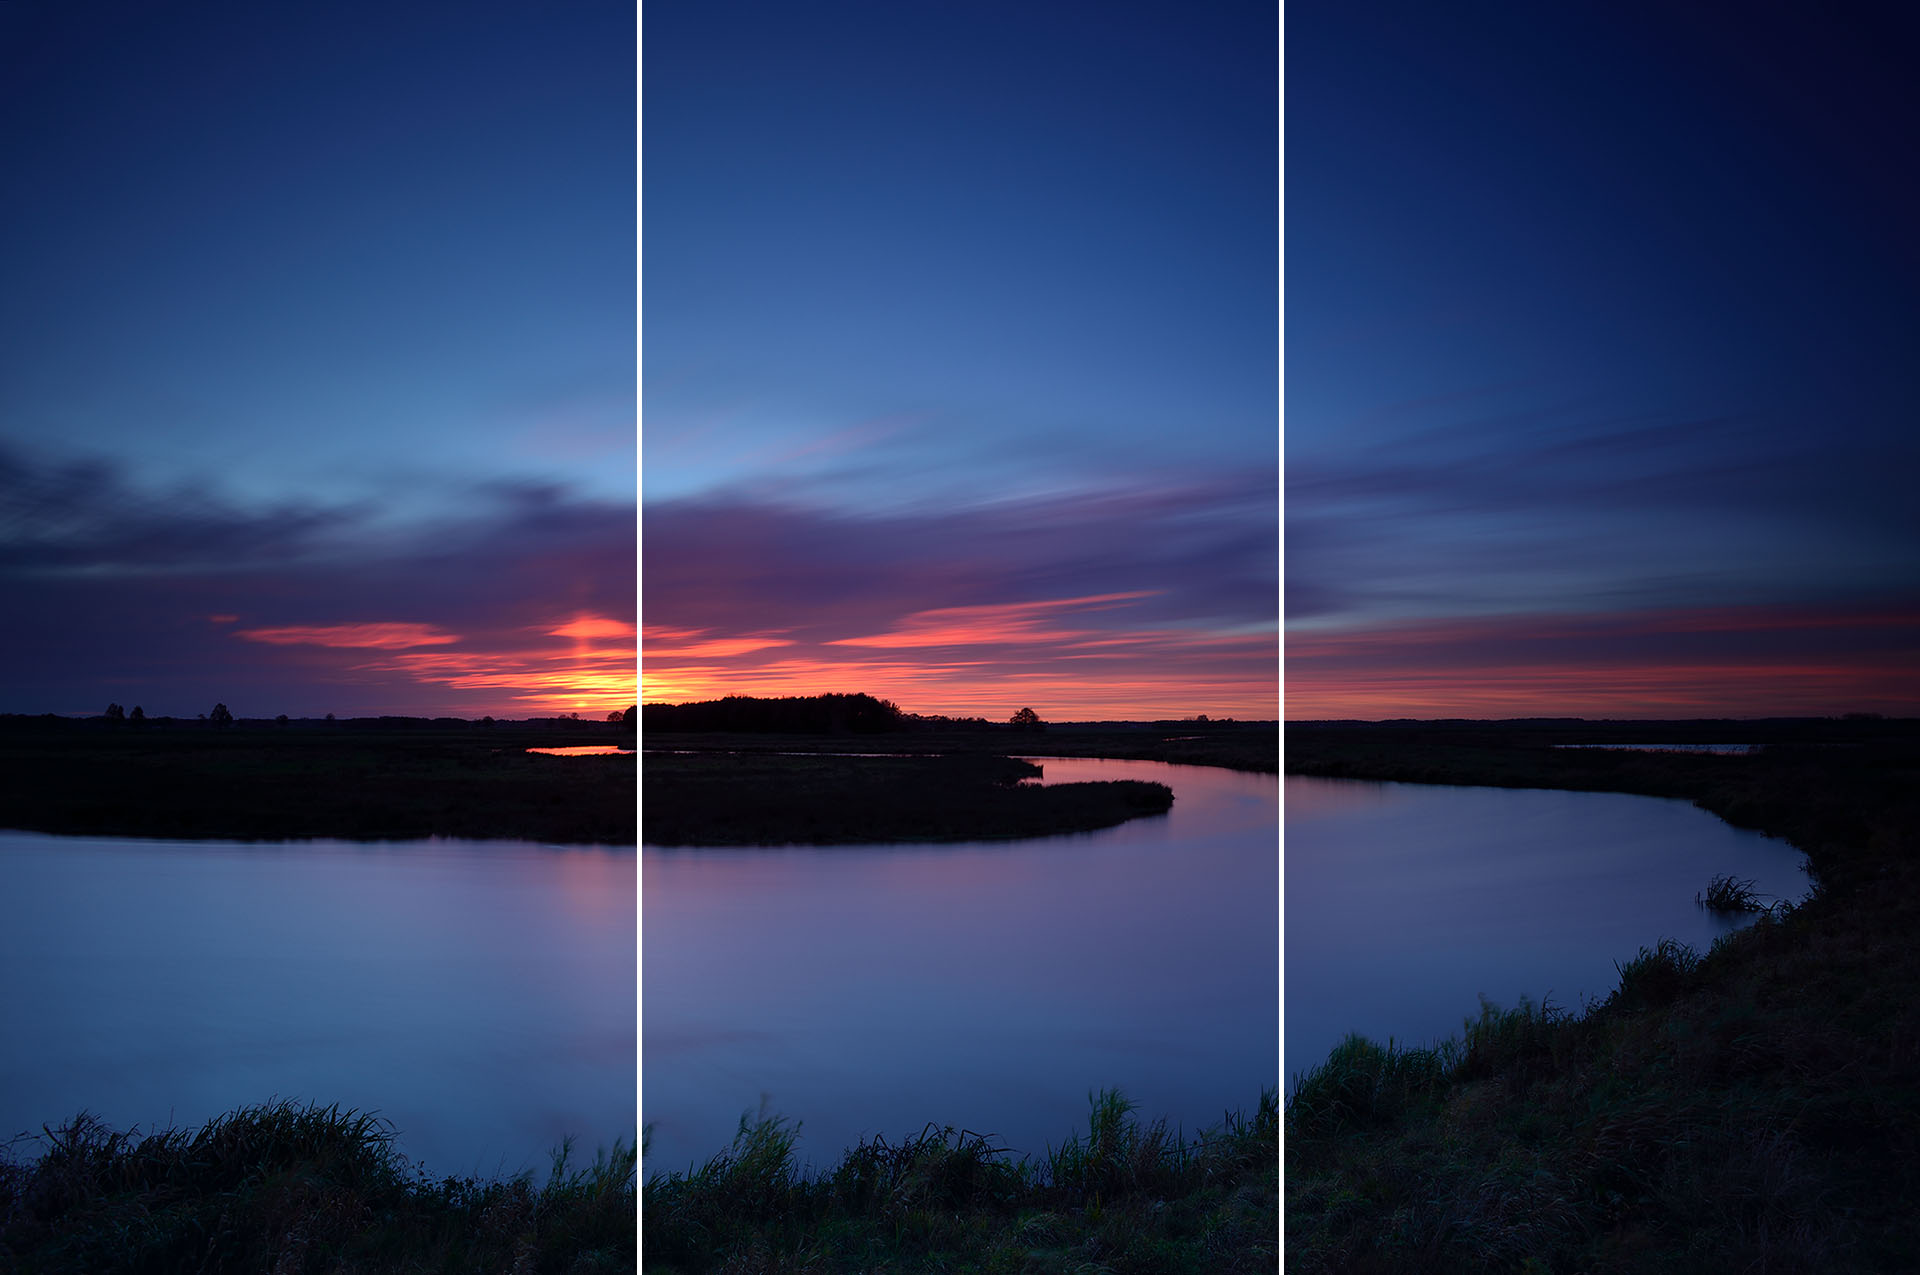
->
[1286,776,1807,1077]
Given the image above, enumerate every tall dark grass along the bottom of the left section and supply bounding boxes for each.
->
[0,1102,636,1275]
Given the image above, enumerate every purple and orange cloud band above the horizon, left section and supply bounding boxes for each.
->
[0,449,636,716]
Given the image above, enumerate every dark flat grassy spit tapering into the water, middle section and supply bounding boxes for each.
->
[641,741,1173,845]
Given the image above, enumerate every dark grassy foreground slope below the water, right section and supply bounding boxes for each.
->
[1284,899,1920,1273]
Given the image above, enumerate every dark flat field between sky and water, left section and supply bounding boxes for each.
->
[0,718,636,845]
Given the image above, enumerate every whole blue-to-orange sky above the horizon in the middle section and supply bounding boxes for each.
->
[641,2,1281,720]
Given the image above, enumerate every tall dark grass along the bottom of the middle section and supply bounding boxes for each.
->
[641,1091,1281,1275]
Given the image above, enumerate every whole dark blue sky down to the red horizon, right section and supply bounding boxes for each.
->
[1284,0,1920,718]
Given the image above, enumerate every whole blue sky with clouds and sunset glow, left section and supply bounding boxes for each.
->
[0,0,637,718]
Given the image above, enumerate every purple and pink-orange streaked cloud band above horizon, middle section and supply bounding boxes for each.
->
[641,476,1279,718]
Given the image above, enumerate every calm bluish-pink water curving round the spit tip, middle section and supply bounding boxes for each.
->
[641,758,1279,1171]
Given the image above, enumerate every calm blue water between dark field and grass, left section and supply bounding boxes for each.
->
[0,831,636,1175]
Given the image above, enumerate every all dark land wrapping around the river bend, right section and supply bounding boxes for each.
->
[1284,720,1920,1271]
